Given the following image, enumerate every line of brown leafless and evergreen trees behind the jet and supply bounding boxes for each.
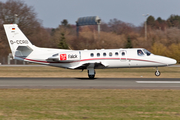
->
[0,0,180,63]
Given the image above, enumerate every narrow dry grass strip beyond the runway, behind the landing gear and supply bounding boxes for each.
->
[0,66,180,78]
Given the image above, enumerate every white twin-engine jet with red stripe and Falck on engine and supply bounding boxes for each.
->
[4,24,176,79]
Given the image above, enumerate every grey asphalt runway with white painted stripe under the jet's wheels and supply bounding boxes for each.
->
[0,78,180,89]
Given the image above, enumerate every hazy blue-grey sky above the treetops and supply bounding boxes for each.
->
[0,0,180,28]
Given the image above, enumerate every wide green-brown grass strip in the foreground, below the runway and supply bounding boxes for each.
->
[0,89,180,120]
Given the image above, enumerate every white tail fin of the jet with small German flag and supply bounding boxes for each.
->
[4,24,34,58]
